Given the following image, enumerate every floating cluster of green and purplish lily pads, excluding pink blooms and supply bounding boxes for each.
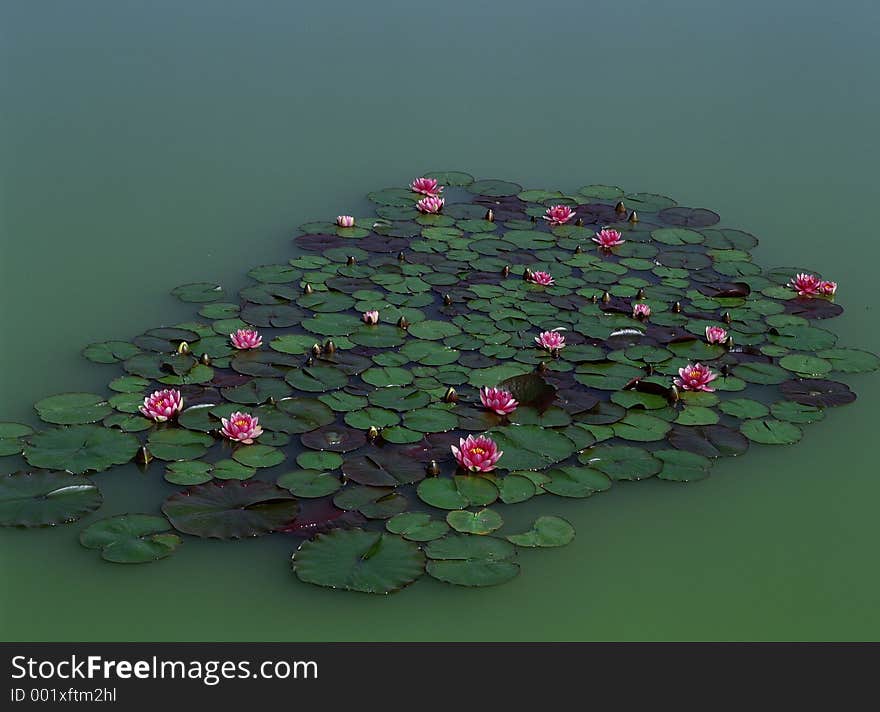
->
[0,177,880,593]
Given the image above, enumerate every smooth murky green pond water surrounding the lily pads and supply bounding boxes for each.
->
[0,0,880,640]
